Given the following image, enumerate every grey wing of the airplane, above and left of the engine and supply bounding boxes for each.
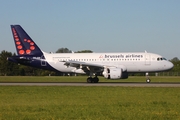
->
[64,61,104,73]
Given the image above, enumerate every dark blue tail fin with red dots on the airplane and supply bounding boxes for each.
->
[11,25,43,56]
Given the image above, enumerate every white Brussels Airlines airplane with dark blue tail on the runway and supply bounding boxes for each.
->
[7,25,174,83]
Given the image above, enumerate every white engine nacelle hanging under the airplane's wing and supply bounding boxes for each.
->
[103,68,128,79]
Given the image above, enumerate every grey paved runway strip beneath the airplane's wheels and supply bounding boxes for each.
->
[0,82,180,87]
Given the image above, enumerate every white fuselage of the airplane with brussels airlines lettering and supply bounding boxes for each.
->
[43,52,173,72]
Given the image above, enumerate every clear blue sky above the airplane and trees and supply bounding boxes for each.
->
[0,0,180,60]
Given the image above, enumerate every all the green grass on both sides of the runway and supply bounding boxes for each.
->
[0,77,180,120]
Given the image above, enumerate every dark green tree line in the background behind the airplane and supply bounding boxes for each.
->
[0,48,180,76]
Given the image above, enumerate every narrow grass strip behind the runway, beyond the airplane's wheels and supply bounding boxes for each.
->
[0,76,180,82]
